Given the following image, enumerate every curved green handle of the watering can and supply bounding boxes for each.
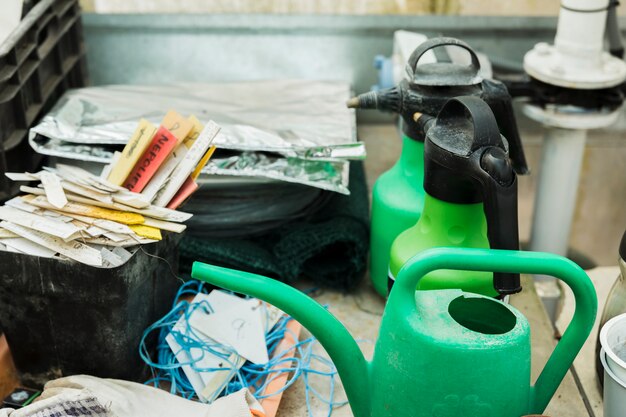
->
[389,248,598,414]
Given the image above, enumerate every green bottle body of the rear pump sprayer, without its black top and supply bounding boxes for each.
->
[370,135,425,296]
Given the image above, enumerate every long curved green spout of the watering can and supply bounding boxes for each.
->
[191,262,370,417]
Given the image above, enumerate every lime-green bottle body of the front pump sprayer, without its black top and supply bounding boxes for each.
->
[387,194,498,297]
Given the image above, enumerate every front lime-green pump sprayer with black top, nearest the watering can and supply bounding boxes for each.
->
[389,96,521,296]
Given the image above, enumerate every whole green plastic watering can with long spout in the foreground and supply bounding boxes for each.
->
[192,248,597,417]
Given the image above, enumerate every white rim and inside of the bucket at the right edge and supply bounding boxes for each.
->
[600,314,626,383]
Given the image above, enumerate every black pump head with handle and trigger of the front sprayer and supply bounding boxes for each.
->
[424,96,521,295]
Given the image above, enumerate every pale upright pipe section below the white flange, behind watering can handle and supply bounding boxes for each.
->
[530,127,587,272]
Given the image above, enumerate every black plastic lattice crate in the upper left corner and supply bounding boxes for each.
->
[0,0,87,201]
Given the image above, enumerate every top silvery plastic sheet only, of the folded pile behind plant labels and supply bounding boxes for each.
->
[32,80,365,159]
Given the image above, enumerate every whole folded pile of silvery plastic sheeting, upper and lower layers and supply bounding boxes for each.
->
[29,80,365,194]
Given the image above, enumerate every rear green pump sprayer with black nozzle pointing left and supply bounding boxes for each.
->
[348,37,528,296]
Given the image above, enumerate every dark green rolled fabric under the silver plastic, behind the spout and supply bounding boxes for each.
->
[180,162,369,290]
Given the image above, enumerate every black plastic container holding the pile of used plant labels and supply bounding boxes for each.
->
[0,233,181,387]
